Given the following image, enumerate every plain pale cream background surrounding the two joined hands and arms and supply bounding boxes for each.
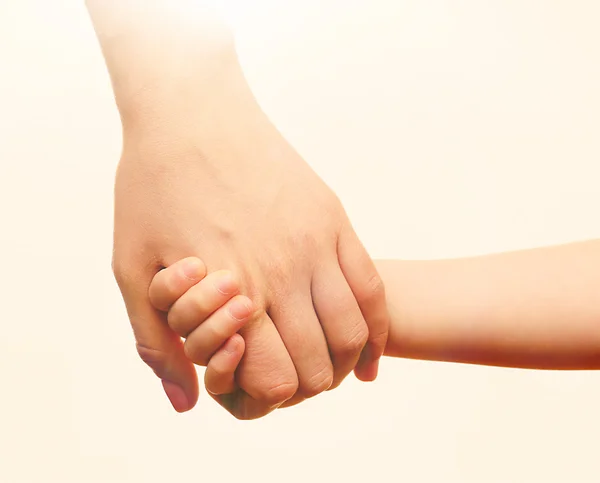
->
[0,0,600,483]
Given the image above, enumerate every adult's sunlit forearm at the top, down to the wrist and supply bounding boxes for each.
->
[86,0,248,129]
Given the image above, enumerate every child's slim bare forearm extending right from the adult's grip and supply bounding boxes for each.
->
[377,240,600,369]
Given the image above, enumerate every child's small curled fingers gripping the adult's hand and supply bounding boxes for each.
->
[149,257,254,411]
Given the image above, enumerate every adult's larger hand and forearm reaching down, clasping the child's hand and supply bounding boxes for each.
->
[87,0,389,419]
